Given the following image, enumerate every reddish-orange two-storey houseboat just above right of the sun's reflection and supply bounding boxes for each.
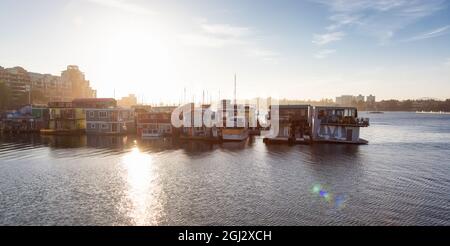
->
[136,107,176,138]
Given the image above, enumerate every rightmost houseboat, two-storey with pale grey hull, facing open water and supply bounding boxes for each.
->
[312,107,369,144]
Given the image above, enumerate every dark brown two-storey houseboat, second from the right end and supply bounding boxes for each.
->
[263,105,312,144]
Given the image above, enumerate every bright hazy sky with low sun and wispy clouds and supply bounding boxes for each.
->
[0,0,450,103]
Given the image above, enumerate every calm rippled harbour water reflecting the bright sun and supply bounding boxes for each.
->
[0,113,450,225]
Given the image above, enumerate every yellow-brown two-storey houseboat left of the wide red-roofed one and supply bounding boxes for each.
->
[40,102,86,135]
